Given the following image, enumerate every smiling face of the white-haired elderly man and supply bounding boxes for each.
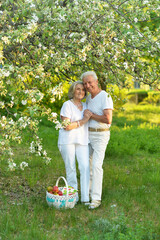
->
[83,76,98,94]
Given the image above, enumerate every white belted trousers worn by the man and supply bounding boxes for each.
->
[89,131,110,201]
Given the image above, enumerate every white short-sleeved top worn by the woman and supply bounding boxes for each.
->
[58,100,89,145]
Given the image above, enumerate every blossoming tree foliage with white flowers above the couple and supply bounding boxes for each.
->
[0,0,160,169]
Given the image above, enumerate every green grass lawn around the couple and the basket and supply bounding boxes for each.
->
[0,104,160,240]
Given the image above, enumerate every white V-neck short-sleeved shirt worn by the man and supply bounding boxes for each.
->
[86,90,113,129]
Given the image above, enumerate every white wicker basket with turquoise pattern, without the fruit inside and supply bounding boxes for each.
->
[46,177,77,209]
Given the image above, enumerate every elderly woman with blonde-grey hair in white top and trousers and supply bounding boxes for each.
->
[58,81,91,204]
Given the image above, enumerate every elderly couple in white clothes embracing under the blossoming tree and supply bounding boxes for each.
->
[58,71,113,209]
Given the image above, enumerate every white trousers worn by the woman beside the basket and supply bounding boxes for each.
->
[58,144,90,202]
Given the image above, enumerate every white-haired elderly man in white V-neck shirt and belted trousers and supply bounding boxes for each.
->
[81,71,113,209]
